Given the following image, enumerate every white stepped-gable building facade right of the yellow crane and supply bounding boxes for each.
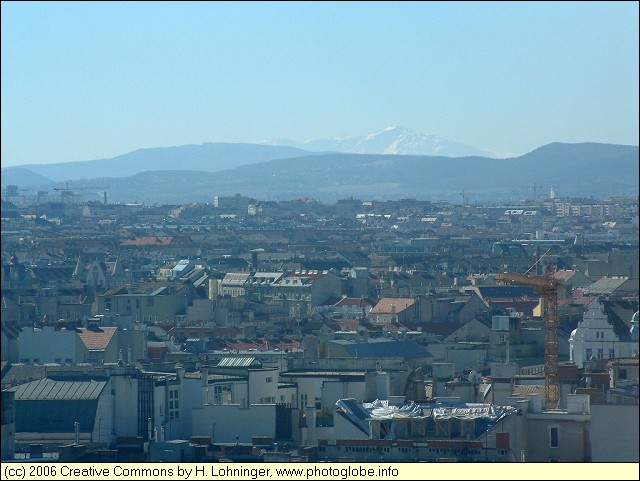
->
[569,300,638,368]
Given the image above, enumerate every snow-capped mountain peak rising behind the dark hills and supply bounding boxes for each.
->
[265,127,498,157]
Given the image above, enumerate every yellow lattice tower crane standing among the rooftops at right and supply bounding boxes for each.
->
[496,250,560,409]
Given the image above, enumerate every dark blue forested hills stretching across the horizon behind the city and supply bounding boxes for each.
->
[2,143,639,204]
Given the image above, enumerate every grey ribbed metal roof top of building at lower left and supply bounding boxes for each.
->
[12,379,107,401]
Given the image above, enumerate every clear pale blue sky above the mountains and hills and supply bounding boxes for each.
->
[0,2,639,167]
